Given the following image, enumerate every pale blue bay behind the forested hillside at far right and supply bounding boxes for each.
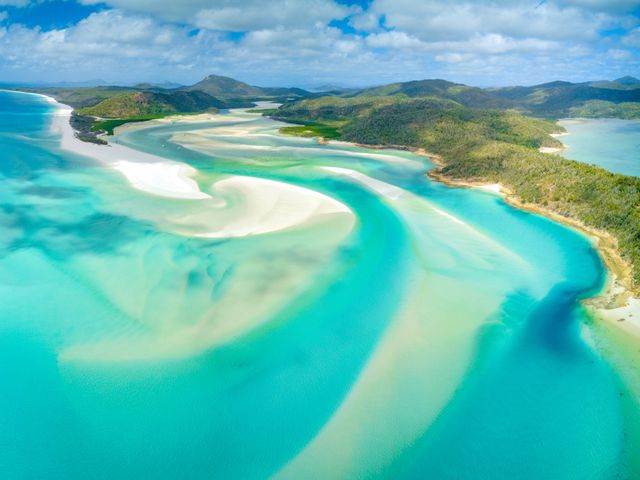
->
[559,118,640,177]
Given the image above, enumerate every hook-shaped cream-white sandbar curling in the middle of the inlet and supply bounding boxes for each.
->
[194,176,353,238]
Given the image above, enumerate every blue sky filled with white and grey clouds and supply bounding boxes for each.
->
[0,0,640,88]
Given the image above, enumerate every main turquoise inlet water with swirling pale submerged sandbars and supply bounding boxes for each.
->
[0,92,634,479]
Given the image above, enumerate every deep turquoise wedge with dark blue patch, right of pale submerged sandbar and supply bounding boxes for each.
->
[398,283,622,480]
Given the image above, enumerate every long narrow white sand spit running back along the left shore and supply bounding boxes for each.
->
[42,95,210,200]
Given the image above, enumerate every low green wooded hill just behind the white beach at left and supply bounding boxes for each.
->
[78,91,226,118]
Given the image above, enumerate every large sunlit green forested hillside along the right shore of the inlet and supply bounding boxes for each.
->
[272,97,640,289]
